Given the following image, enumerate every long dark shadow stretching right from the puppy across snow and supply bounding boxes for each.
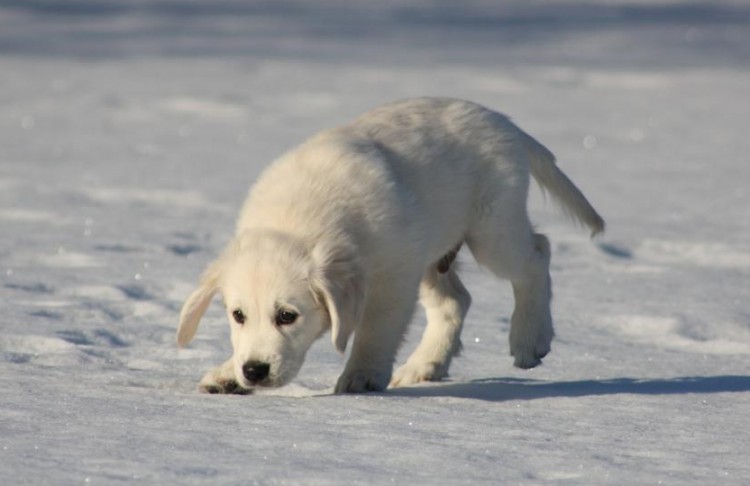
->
[386,375,750,402]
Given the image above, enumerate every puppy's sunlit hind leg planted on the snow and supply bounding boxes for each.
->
[390,262,471,387]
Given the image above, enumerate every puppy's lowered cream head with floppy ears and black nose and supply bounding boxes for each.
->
[177,232,364,388]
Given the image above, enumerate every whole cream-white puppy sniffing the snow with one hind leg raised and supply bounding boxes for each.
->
[177,98,604,393]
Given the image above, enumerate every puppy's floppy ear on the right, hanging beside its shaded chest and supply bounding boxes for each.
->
[311,239,365,353]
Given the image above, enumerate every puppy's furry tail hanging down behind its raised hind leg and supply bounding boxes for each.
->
[519,130,604,237]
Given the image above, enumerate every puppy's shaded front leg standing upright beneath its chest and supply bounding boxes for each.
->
[336,285,416,393]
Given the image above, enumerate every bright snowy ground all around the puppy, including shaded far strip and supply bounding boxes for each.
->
[0,0,750,485]
